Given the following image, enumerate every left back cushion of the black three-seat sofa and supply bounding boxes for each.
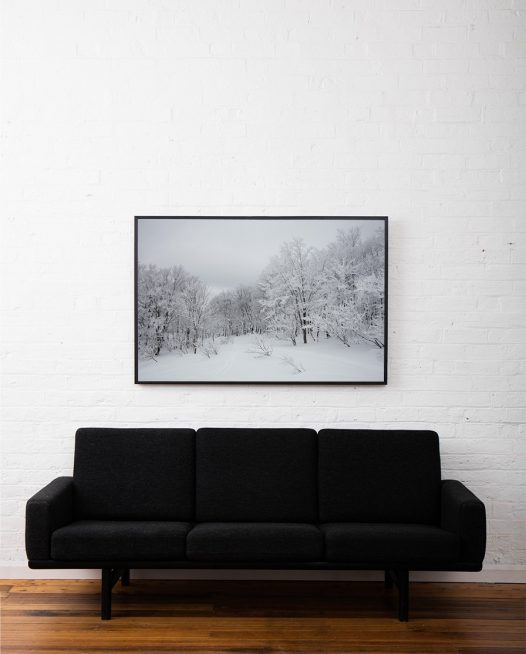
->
[73,428,195,520]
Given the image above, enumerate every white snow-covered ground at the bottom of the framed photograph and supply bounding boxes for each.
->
[139,335,384,382]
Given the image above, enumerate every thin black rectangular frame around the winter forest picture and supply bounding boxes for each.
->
[134,216,388,386]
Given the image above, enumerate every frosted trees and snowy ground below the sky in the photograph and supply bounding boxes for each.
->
[137,220,385,382]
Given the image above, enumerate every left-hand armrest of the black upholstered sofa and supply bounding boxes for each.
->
[26,477,73,561]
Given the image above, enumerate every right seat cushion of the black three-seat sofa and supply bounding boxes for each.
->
[321,523,459,565]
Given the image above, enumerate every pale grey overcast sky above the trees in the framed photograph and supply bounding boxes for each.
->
[138,218,383,295]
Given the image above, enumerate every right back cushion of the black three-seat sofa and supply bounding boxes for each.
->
[318,429,440,524]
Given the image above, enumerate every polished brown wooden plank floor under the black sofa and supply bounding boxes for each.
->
[0,578,526,654]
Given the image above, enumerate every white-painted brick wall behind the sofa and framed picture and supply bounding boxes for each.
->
[0,0,526,578]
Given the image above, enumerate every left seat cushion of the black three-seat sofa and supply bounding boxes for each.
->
[51,520,191,561]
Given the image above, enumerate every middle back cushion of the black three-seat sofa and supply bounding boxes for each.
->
[196,429,317,522]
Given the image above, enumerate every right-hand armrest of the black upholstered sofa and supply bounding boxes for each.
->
[441,479,486,566]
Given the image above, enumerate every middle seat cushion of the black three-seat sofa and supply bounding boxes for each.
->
[186,522,323,562]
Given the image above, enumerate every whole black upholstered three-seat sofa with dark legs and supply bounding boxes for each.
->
[26,428,486,620]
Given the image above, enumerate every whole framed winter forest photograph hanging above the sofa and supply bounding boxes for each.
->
[135,216,387,384]
